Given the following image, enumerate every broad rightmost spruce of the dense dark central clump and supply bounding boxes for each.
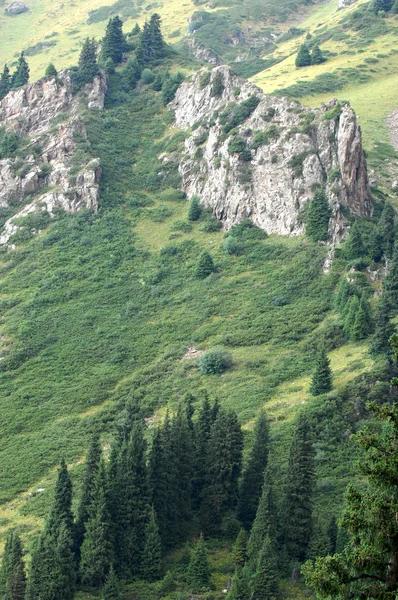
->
[200,409,243,534]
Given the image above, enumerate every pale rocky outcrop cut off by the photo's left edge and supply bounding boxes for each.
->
[0,71,106,244]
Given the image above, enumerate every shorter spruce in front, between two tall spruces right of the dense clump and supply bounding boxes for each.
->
[247,469,277,571]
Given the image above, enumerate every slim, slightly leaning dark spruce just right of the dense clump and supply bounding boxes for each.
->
[238,412,269,529]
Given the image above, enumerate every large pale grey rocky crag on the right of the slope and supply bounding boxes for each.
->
[172,66,373,244]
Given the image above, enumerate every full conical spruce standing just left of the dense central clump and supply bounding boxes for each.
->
[80,461,113,587]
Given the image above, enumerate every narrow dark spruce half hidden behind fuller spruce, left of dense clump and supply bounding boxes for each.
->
[75,433,101,557]
